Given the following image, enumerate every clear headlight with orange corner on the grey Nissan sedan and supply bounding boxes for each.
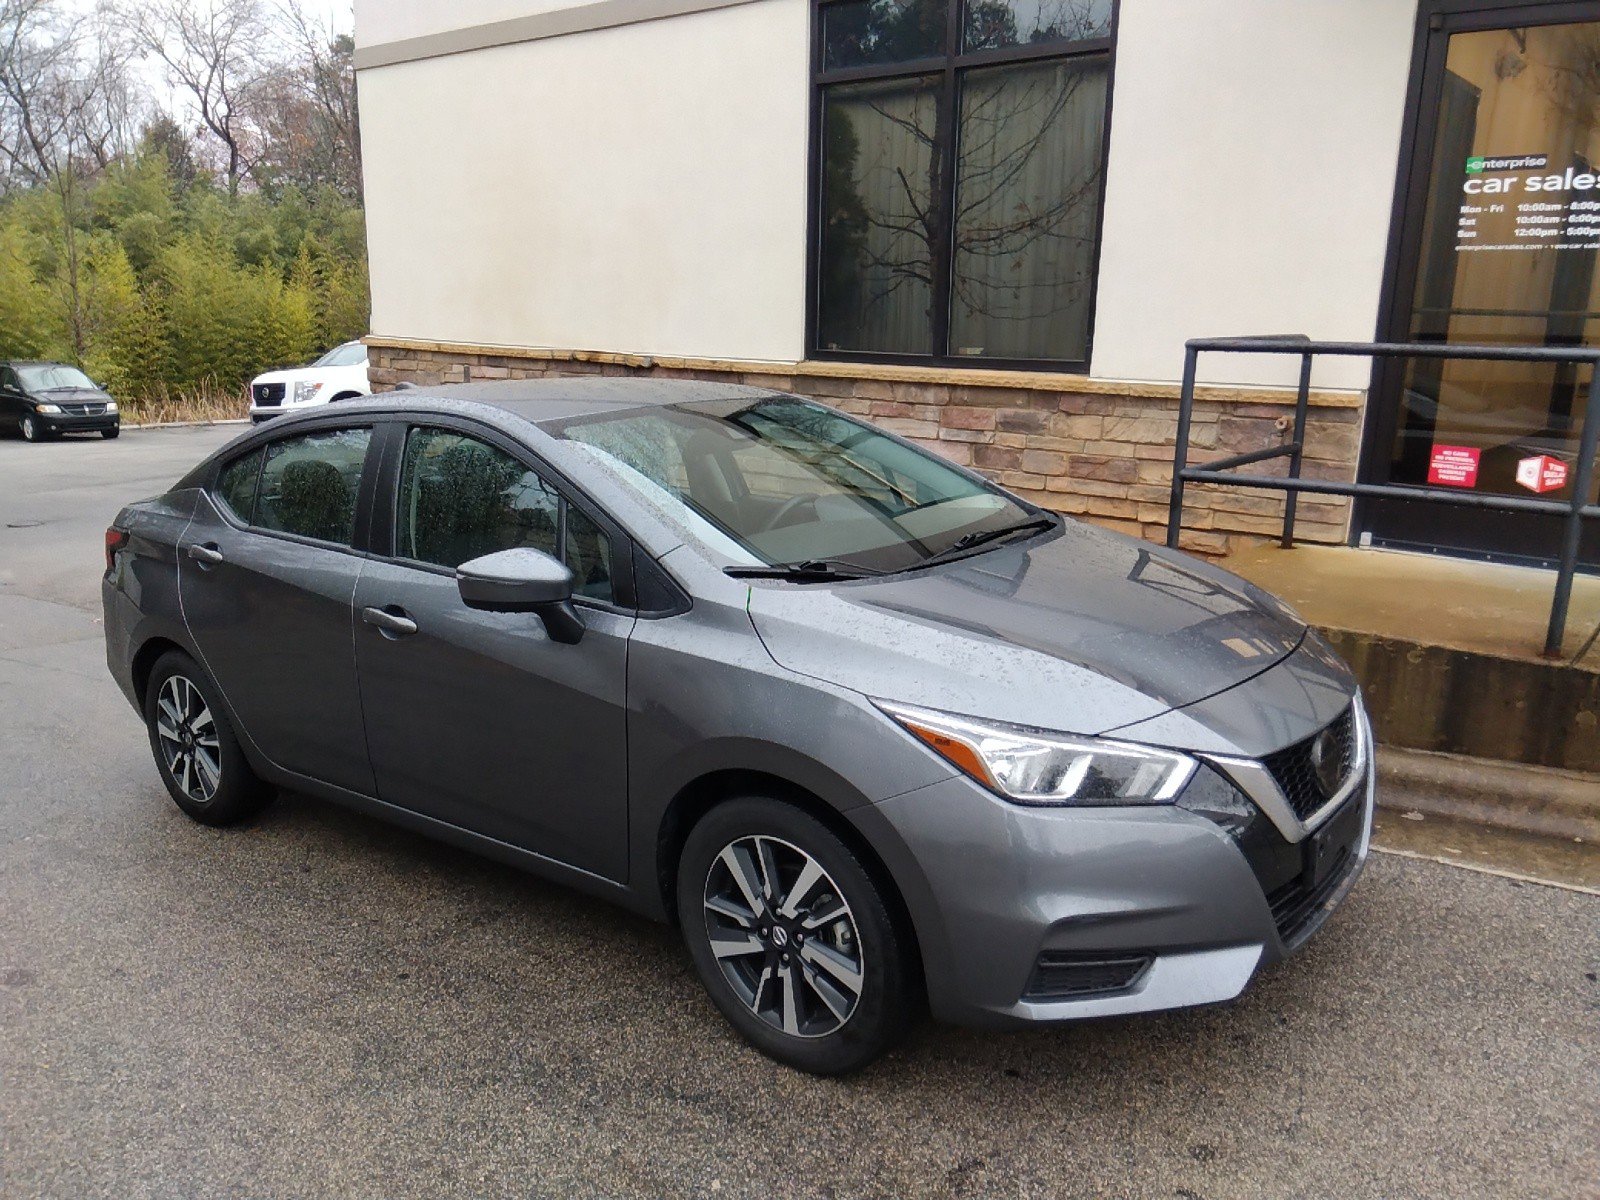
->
[874,701,1195,805]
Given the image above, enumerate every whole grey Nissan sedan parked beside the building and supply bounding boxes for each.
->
[104,379,1373,1072]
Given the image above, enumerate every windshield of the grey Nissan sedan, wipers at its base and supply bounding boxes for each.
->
[549,398,1038,571]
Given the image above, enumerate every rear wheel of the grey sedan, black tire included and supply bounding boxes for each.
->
[144,650,272,826]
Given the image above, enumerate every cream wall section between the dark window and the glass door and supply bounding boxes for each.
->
[1091,0,1416,387]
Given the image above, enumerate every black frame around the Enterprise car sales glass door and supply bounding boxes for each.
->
[1349,0,1600,563]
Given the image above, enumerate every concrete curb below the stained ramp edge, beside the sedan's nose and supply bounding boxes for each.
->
[1378,746,1600,845]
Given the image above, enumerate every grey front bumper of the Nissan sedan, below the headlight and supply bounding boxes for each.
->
[851,723,1374,1026]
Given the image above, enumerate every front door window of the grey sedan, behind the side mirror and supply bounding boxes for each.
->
[395,427,611,602]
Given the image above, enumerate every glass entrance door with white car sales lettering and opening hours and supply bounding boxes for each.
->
[1360,3,1600,565]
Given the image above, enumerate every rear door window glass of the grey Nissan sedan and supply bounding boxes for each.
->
[253,429,373,546]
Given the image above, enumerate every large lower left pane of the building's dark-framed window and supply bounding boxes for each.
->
[818,77,939,354]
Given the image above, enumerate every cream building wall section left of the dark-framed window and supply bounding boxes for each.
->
[357,0,810,360]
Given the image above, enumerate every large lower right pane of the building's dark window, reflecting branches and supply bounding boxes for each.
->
[950,59,1107,360]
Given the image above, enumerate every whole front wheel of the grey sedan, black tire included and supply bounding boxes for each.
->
[677,797,918,1075]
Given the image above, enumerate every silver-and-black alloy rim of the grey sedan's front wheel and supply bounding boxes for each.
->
[704,835,866,1037]
